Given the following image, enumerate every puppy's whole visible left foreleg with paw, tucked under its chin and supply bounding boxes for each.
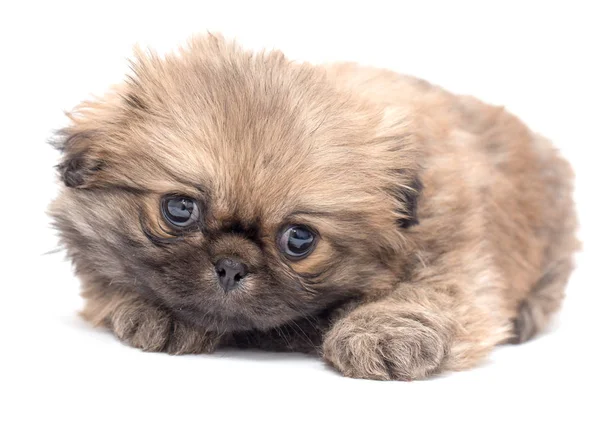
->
[82,281,219,354]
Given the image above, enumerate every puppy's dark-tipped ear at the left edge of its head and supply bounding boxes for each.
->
[52,130,103,188]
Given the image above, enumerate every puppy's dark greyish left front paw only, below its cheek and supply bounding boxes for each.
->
[108,300,218,355]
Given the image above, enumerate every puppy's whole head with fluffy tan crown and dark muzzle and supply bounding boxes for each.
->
[51,37,418,332]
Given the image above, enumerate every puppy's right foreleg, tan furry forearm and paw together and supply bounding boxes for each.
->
[322,278,511,380]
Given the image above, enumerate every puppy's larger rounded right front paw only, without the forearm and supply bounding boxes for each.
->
[323,308,450,380]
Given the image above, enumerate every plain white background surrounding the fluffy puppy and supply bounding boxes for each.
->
[0,0,600,427]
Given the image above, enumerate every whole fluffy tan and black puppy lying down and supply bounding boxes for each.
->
[50,36,578,380]
